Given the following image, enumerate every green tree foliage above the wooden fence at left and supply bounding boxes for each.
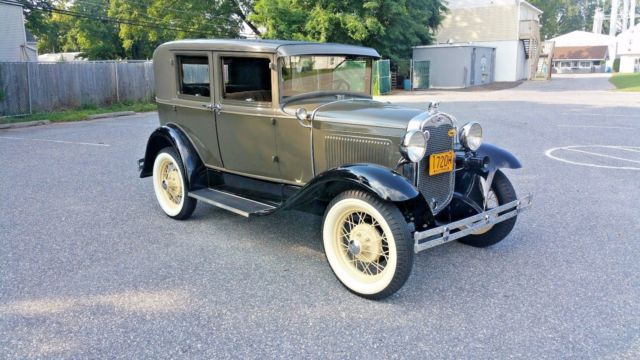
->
[22,0,251,60]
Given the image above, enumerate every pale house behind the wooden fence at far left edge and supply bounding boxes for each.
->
[0,0,38,62]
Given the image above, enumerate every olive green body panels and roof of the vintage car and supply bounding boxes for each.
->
[154,40,416,186]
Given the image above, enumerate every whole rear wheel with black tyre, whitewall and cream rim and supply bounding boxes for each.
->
[153,147,197,220]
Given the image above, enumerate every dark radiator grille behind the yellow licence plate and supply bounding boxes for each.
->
[417,122,455,214]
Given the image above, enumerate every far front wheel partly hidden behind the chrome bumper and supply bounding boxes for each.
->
[460,170,518,247]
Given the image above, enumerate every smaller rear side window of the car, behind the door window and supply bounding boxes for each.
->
[177,56,211,100]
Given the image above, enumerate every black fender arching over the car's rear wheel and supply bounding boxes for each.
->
[140,124,206,190]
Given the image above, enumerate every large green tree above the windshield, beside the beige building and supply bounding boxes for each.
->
[249,0,445,60]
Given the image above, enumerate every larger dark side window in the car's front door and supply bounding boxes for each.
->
[222,57,271,102]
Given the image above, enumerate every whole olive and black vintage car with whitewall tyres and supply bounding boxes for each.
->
[138,40,531,299]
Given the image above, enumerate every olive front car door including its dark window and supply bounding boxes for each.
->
[214,52,280,180]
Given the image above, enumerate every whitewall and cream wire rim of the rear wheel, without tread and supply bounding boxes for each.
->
[153,153,184,216]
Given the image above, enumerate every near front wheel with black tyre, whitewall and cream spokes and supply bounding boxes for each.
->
[322,190,413,299]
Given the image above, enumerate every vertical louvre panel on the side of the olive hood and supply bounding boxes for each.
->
[324,136,391,169]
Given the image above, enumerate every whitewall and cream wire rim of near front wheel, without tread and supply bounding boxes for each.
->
[323,199,397,294]
